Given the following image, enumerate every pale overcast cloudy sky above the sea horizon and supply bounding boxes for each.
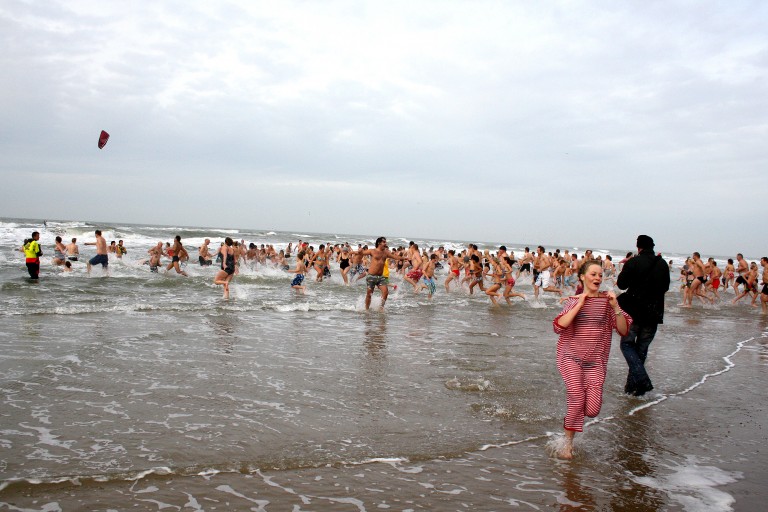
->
[0,0,768,257]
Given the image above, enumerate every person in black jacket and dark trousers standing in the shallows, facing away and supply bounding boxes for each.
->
[616,235,669,396]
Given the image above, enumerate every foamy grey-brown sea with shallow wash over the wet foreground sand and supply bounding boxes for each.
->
[0,218,768,512]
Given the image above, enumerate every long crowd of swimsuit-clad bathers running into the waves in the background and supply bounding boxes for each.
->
[21,230,768,312]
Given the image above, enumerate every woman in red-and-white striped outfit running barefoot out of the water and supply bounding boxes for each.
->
[553,260,632,459]
